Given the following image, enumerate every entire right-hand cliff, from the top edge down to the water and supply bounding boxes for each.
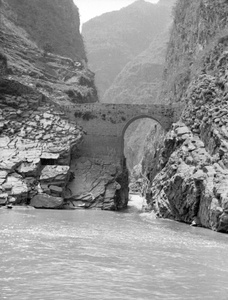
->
[148,0,228,232]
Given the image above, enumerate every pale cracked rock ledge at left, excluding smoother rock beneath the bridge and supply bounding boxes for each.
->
[0,91,82,208]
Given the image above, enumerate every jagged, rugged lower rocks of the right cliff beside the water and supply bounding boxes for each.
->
[149,72,228,232]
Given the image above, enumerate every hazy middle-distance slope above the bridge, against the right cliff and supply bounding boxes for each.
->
[102,28,171,104]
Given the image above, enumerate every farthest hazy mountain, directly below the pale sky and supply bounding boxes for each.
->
[82,0,173,102]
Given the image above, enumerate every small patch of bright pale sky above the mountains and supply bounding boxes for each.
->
[74,0,159,23]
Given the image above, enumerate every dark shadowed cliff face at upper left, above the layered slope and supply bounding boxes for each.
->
[2,0,87,61]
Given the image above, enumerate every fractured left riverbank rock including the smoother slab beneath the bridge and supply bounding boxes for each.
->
[0,76,128,210]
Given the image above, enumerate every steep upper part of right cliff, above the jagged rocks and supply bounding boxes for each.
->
[162,0,227,102]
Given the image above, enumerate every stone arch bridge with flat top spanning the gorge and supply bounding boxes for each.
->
[67,103,181,162]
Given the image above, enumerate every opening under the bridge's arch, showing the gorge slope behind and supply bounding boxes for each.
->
[122,116,165,196]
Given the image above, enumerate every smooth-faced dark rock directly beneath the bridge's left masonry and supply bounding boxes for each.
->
[64,157,128,210]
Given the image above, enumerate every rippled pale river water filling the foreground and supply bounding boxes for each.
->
[0,197,228,300]
